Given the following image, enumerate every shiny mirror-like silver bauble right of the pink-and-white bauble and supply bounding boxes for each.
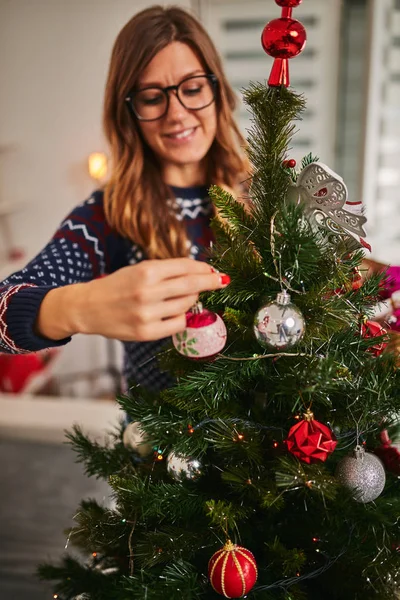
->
[254,291,305,350]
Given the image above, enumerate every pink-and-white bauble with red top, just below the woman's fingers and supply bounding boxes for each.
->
[172,302,227,359]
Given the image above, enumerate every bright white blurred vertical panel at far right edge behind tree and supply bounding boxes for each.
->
[363,0,400,264]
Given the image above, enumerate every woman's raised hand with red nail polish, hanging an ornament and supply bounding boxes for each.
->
[36,258,230,342]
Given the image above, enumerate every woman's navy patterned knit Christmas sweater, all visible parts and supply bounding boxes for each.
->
[0,186,216,390]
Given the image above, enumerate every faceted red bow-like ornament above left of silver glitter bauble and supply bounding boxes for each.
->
[286,409,337,464]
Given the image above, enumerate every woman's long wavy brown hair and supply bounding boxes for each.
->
[104,6,247,258]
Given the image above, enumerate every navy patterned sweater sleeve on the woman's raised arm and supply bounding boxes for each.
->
[0,192,122,354]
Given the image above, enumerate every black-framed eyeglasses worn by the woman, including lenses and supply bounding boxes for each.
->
[125,74,218,121]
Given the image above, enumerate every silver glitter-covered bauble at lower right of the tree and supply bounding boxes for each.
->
[335,446,386,504]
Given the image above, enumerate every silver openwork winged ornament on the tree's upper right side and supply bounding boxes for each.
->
[287,162,367,251]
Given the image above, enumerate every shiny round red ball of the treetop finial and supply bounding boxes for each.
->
[261,18,307,58]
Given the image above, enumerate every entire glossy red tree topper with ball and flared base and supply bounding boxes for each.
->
[261,0,307,87]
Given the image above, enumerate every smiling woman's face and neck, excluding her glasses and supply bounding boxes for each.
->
[137,42,217,186]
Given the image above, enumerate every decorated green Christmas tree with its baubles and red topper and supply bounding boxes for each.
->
[40,0,400,600]
